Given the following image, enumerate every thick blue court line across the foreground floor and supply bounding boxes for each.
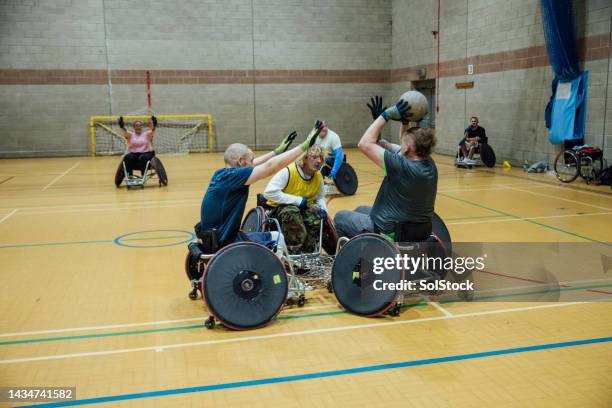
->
[21,337,612,407]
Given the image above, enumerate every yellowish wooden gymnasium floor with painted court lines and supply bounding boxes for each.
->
[0,150,612,407]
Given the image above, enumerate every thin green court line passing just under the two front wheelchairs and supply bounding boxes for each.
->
[0,284,612,347]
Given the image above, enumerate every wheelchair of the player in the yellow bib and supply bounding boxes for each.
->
[242,194,338,289]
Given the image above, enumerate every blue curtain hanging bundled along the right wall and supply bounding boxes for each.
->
[541,0,588,143]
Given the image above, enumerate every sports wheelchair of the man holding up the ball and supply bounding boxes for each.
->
[332,213,473,317]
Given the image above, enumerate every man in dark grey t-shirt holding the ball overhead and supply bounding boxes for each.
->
[334,97,438,241]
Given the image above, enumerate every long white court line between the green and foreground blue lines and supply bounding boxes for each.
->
[0,301,593,364]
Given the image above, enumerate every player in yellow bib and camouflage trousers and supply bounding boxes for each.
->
[264,143,327,254]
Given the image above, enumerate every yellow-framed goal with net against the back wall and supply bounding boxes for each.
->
[89,114,213,156]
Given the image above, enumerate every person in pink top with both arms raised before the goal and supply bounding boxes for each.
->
[119,116,157,176]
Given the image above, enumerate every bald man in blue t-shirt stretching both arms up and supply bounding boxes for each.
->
[199,121,322,247]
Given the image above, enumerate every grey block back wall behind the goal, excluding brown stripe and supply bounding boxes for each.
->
[0,0,391,157]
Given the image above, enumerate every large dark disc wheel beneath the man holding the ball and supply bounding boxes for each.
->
[331,233,403,316]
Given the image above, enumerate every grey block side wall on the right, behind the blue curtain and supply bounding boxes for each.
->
[391,0,612,163]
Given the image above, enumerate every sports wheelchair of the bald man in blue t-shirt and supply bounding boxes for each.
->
[185,220,306,330]
